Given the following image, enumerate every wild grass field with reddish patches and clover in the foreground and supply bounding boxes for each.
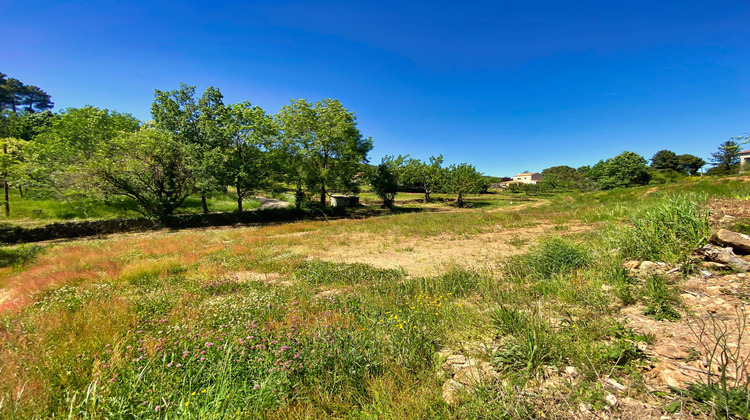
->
[0,179,750,419]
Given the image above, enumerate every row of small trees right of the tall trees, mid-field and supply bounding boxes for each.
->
[370,155,488,207]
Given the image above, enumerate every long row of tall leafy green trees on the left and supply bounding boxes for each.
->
[0,85,372,217]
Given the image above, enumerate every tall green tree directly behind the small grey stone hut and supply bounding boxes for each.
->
[277,99,372,205]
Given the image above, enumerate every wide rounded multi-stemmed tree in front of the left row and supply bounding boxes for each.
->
[86,128,196,218]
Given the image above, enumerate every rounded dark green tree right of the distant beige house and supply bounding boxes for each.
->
[589,152,651,190]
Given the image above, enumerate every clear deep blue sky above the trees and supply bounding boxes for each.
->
[0,0,750,176]
